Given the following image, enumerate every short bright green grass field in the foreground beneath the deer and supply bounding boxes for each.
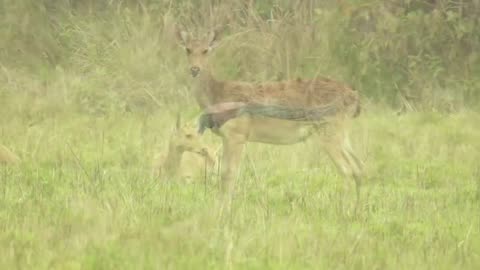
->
[0,108,480,269]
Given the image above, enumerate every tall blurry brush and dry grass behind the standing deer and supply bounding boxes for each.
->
[0,0,480,118]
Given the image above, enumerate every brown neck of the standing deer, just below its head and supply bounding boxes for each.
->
[194,69,223,109]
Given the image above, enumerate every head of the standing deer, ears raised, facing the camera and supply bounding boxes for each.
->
[177,29,219,77]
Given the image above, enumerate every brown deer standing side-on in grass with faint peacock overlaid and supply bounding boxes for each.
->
[177,29,362,205]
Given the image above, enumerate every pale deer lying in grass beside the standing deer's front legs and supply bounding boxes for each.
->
[153,115,216,182]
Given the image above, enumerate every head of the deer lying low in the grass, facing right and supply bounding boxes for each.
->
[169,116,211,158]
